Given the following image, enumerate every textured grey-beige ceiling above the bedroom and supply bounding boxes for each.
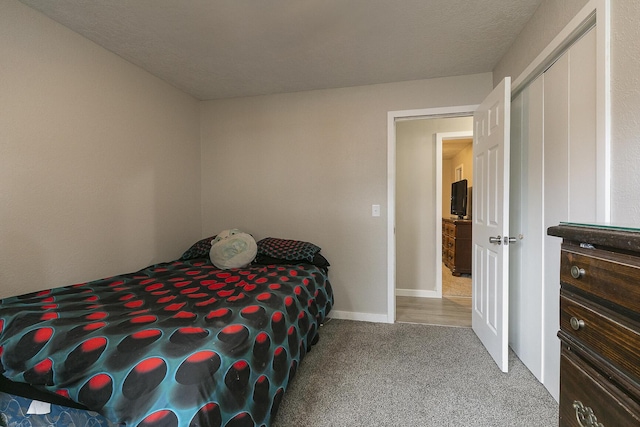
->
[21,0,541,99]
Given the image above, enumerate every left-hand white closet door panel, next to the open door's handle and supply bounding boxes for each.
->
[509,76,545,381]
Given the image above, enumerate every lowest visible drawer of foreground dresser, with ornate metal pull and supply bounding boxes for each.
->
[559,345,640,427]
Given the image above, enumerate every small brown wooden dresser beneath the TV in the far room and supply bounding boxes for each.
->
[442,218,471,276]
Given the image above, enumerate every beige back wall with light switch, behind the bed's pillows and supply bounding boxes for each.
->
[201,74,491,315]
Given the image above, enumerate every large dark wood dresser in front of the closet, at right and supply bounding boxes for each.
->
[548,224,640,427]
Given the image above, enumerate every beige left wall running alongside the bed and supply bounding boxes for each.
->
[0,0,200,297]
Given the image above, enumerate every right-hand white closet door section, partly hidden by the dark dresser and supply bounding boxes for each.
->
[543,29,597,398]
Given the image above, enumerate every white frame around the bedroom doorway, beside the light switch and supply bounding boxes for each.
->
[387,105,478,323]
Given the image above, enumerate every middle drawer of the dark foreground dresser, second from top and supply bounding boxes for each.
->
[560,289,640,379]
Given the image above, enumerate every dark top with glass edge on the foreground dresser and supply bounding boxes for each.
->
[547,222,640,252]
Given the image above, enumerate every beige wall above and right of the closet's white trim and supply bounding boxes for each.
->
[494,0,640,227]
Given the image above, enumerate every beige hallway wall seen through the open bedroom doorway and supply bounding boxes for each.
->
[396,117,473,294]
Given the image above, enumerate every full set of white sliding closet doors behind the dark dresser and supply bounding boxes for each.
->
[510,29,598,400]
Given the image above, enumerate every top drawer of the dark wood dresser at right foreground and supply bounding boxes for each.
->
[560,245,640,314]
